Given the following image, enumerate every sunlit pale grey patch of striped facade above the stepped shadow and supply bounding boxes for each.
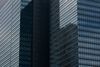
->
[59,0,77,28]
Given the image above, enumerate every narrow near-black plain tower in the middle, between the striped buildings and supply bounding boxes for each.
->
[33,0,49,67]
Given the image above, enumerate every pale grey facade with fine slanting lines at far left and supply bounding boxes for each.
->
[0,0,20,67]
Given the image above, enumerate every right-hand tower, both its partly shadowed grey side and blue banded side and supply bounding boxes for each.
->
[50,0,100,67]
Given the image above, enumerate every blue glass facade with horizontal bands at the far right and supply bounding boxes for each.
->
[78,0,100,67]
